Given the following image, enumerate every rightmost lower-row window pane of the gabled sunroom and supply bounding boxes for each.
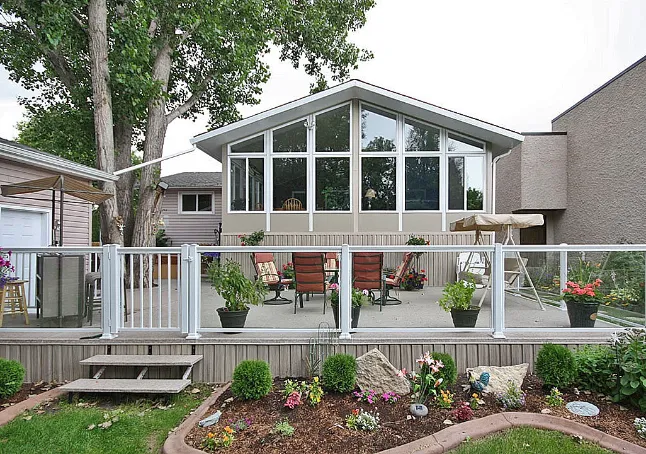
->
[448,156,484,210]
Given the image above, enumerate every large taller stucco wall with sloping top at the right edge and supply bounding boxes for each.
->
[552,61,646,247]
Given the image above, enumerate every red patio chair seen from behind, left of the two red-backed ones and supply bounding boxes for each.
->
[292,252,328,314]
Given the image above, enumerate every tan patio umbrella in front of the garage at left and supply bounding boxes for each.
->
[0,175,112,246]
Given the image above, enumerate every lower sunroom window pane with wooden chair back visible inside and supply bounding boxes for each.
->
[273,158,307,211]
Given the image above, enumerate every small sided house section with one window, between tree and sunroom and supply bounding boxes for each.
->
[161,172,222,246]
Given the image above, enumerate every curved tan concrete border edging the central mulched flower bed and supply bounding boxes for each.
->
[162,383,646,454]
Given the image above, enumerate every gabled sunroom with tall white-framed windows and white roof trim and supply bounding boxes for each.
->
[194,80,523,239]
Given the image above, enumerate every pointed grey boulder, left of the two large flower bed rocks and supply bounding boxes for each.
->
[357,348,410,396]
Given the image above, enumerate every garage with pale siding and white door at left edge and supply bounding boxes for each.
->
[0,138,118,249]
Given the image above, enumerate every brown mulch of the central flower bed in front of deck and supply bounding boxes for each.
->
[186,375,646,454]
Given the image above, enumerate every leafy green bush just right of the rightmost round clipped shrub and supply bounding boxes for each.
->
[574,345,617,394]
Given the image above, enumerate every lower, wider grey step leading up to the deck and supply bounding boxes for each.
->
[61,378,191,394]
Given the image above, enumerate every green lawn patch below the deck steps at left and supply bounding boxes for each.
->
[0,386,210,454]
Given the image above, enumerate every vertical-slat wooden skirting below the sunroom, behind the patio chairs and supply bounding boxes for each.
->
[221,232,491,286]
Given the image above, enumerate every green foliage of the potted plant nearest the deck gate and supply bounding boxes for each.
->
[207,259,267,311]
